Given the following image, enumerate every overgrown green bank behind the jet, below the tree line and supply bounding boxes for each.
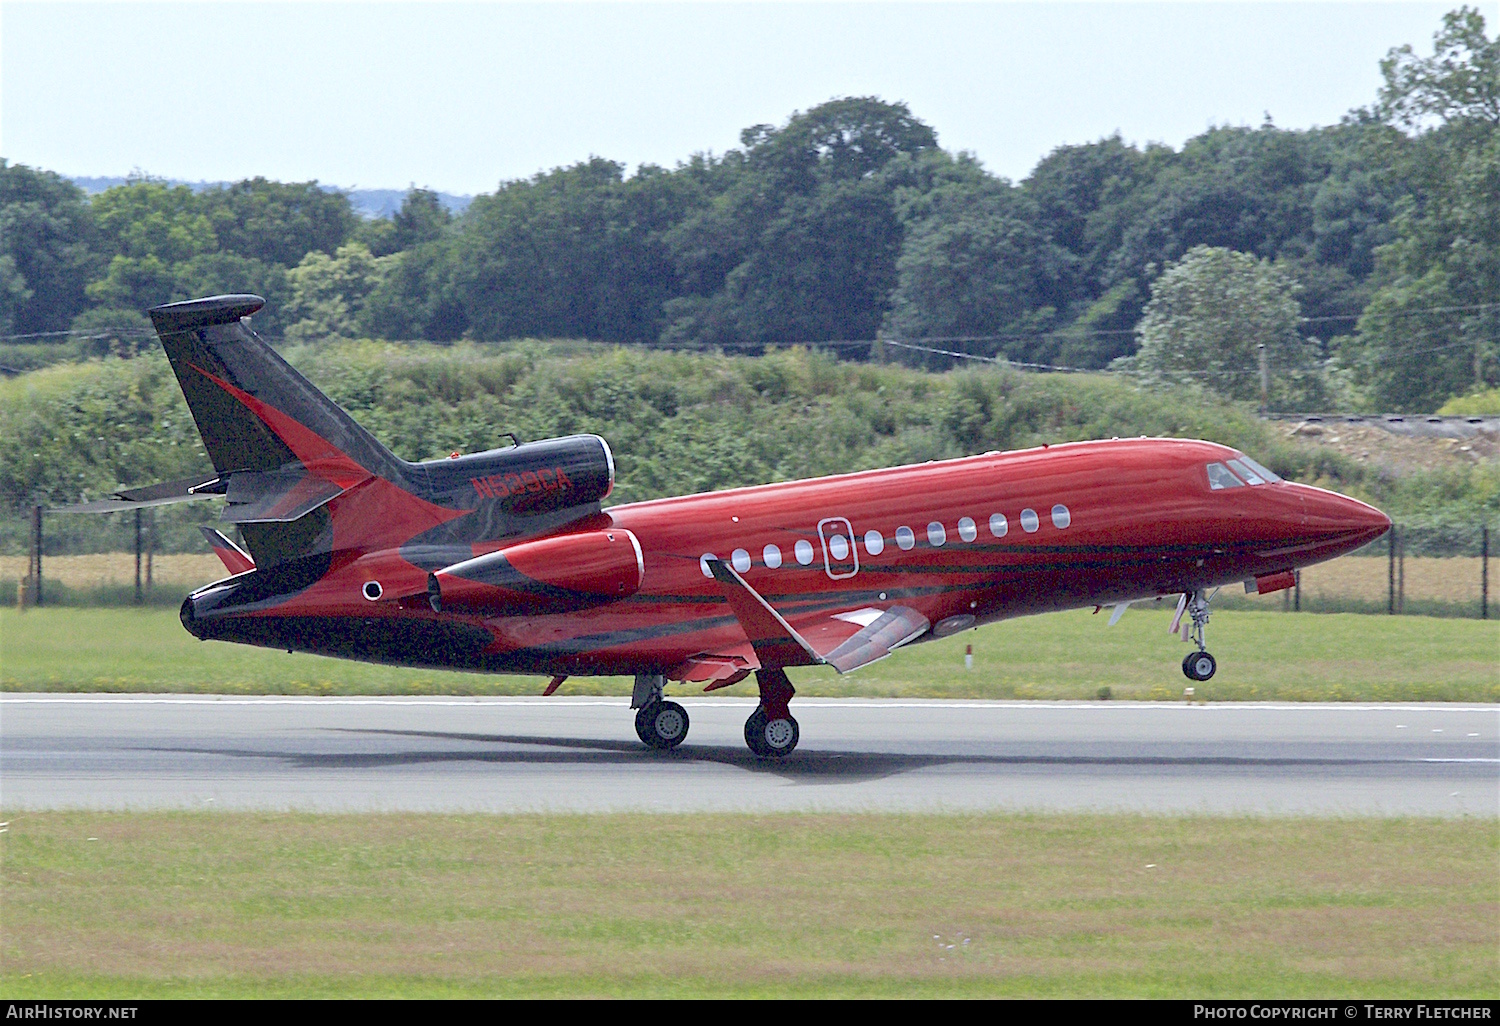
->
[0,342,1500,552]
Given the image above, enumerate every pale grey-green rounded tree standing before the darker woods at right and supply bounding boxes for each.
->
[1133,246,1323,410]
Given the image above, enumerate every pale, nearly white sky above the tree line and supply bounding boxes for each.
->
[0,0,1476,194]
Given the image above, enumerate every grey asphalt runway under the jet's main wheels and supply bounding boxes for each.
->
[0,695,1500,818]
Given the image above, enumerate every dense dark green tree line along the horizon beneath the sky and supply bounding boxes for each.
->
[0,8,1500,410]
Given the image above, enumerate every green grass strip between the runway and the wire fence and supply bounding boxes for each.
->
[0,608,1500,702]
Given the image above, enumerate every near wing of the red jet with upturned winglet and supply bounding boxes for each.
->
[708,560,932,674]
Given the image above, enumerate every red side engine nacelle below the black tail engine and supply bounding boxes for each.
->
[428,528,645,617]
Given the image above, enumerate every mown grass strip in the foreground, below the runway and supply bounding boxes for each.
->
[0,812,1500,999]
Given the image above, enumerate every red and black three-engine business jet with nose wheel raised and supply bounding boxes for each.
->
[69,296,1391,758]
